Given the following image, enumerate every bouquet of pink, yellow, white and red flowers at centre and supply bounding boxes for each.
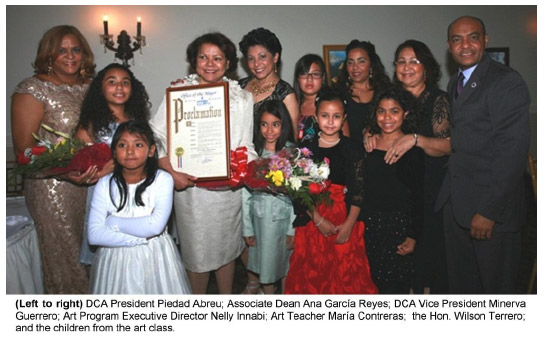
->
[245,148,330,210]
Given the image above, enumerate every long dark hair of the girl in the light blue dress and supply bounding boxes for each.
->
[253,100,293,156]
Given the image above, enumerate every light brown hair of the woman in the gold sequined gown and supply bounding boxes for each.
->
[32,25,96,78]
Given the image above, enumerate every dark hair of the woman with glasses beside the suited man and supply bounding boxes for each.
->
[393,40,442,87]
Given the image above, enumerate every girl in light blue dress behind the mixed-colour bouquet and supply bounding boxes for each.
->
[242,100,294,294]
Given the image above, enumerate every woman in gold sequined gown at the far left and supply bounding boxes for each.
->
[11,25,97,294]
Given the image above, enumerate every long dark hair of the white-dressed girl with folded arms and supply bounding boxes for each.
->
[110,121,159,211]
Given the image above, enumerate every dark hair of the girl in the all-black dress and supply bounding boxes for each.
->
[368,85,418,135]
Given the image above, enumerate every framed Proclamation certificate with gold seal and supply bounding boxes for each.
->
[166,82,231,181]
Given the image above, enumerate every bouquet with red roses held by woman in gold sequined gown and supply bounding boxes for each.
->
[13,124,112,177]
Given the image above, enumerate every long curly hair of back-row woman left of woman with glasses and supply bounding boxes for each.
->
[338,39,391,92]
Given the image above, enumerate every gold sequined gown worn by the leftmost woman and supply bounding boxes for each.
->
[15,77,89,294]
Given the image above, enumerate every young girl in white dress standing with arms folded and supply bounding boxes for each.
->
[88,121,191,294]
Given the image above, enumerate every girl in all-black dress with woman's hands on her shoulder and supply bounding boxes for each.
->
[361,87,424,294]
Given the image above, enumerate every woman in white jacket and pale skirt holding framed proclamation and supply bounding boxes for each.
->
[150,33,256,294]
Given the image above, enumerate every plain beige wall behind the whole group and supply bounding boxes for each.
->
[6,6,537,155]
